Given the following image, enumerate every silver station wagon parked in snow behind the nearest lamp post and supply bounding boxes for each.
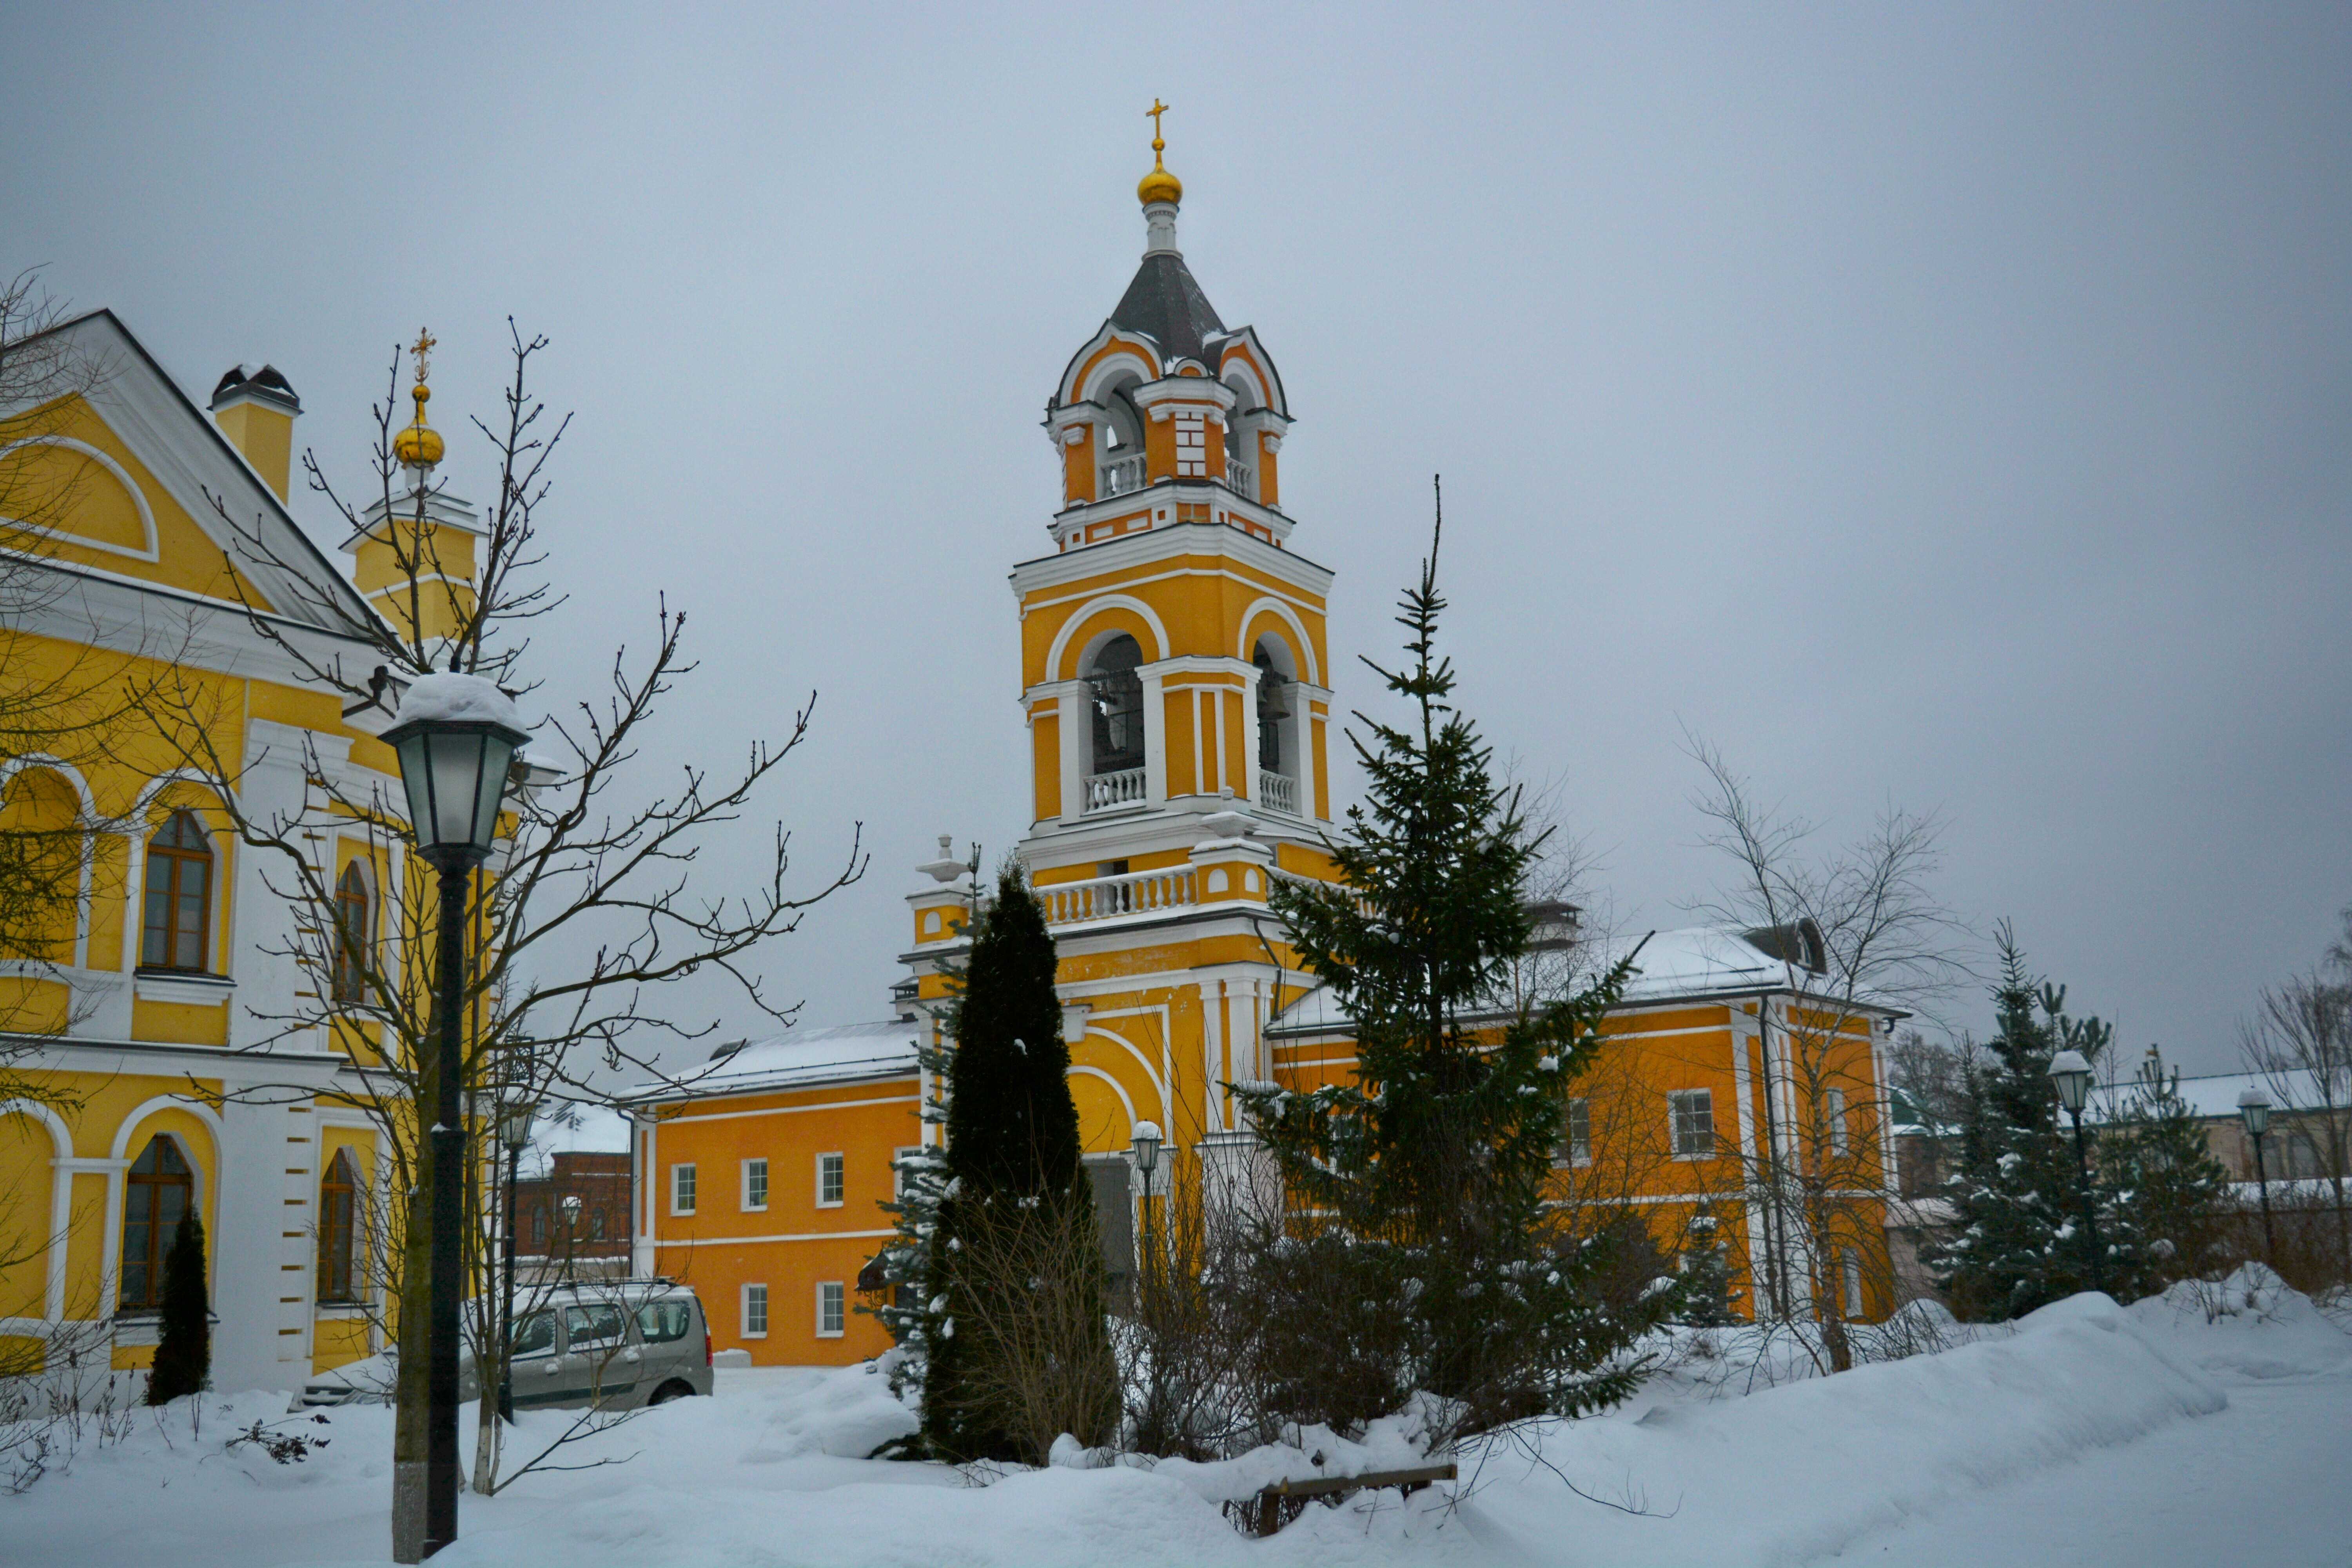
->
[294,1279,710,1410]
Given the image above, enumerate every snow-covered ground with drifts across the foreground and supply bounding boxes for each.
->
[0,1279,2352,1568]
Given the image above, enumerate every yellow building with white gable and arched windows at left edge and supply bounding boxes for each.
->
[0,310,466,1389]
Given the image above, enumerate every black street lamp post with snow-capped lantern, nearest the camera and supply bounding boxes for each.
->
[383,672,529,1556]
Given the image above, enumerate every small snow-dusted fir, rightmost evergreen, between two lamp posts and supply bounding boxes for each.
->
[2098,1046,2230,1295]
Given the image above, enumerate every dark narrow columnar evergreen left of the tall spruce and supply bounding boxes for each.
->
[922,865,1117,1462]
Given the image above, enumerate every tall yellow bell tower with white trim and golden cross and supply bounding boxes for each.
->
[908,101,1334,1253]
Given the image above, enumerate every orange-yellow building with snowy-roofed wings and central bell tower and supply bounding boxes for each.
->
[635,141,1886,1363]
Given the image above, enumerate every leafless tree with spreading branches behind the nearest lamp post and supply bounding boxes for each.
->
[138,332,866,1561]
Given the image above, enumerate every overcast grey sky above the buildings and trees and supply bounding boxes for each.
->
[0,5,2352,1067]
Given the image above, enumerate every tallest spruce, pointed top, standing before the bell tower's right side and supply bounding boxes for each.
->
[1232,501,1682,1446]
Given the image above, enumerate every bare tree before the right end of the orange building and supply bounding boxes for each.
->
[1689,738,1966,1370]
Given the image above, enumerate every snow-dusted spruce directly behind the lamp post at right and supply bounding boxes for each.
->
[1924,924,2138,1321]
